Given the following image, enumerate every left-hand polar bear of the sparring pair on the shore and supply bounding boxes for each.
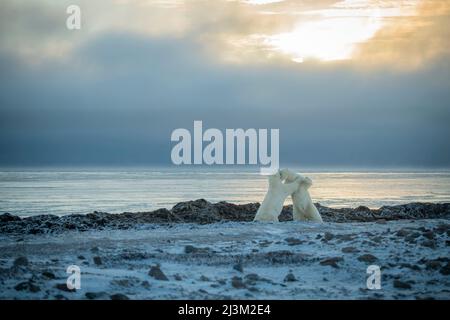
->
[253,171,300,222]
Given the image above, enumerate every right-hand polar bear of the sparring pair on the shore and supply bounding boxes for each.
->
[280,169,323,222]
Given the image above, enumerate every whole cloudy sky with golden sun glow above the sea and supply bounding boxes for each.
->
[0,0,450,168]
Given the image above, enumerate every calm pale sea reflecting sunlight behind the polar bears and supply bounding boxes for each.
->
[0,167,450,216]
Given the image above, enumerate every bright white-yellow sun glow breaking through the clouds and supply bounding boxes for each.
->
[263,17,382,62]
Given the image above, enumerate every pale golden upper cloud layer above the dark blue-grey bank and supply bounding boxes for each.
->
[0,0,450,69]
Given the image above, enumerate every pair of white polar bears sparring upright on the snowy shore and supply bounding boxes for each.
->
[254,169,323,222]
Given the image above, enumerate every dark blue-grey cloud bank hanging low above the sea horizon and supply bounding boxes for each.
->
[0,29,450,166]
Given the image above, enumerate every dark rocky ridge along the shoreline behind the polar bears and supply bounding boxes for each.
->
[0,199,450,234]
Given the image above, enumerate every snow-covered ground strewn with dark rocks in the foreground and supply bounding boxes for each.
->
[0,219,450,299]
